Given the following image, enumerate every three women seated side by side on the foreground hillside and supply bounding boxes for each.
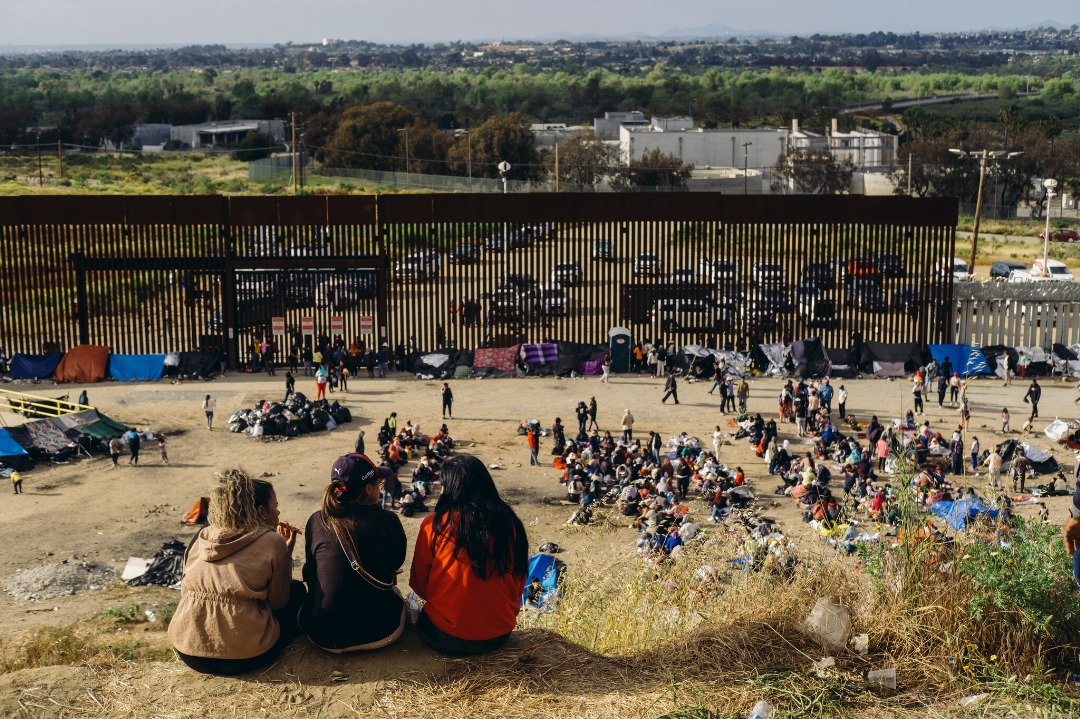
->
[168,452,528,675]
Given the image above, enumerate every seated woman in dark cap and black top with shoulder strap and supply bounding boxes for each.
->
[298,453,406,653]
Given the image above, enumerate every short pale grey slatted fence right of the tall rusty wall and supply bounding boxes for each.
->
[954,281,1080,350]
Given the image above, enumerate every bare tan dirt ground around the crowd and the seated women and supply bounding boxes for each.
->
[0,372,1078,717]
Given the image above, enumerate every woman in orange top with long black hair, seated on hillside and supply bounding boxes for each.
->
[409,455,528,655]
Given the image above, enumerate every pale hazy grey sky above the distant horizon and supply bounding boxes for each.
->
[0,0,1080,46]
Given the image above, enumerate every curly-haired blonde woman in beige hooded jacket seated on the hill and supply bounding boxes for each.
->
[168,470,305,675]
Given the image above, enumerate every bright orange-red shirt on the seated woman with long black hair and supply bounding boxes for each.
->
[409,514,526,641]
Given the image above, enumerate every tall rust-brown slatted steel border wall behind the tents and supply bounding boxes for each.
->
[0,193,957,366]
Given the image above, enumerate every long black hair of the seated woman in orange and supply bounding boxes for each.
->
[432,455,529,580]
